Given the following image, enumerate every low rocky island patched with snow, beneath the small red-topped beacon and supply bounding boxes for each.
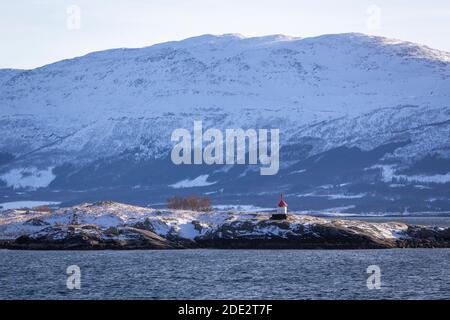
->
[0,201,450,250]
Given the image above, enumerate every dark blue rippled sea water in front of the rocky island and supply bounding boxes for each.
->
[0,249,450,299]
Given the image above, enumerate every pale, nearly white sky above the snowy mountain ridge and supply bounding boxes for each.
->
[0,0,450,68]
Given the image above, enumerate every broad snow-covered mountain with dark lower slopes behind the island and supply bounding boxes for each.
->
[0,34,450,212]
